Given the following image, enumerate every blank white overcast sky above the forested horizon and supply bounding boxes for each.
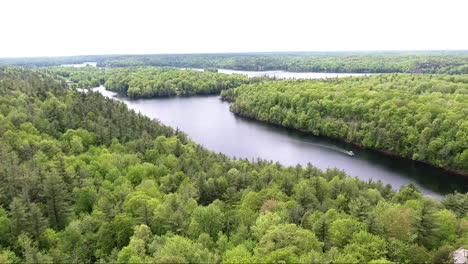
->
[0,0,468,57]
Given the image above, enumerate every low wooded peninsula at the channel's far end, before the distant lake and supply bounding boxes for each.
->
[40,67,258,98]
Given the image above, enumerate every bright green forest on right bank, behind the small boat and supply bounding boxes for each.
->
[223,74,468,174]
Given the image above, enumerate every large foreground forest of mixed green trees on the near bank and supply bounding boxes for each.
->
[0,68,468,263]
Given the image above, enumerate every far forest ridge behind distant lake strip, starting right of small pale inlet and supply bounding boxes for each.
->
[99,53,468,74]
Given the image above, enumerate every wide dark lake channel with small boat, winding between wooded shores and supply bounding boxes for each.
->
[96,84,468,196]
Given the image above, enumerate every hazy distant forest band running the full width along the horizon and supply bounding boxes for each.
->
[0,51,468,74]
